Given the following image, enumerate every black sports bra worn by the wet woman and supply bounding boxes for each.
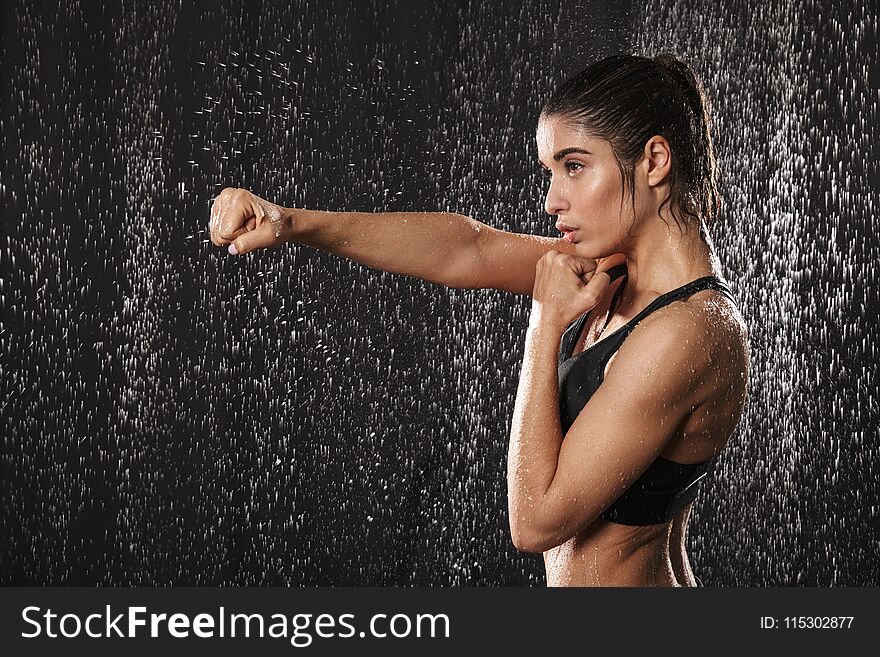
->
[558,264,736,525]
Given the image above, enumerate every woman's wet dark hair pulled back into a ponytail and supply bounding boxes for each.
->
[541,54,720,234]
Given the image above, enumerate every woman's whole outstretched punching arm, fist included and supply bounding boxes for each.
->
[211,188,622,294]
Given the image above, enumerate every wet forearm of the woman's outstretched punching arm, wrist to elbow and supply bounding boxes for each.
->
[291,209,489,287]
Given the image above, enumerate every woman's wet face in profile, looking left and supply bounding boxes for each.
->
[536,116,639,258]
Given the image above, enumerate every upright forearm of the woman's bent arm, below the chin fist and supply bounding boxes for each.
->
[507,321,563,551]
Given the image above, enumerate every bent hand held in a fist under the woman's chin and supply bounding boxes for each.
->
[531,251,611,334]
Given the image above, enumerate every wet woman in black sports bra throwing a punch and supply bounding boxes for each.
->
[211,55,748,586]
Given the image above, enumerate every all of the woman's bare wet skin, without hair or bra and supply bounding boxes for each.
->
[210,119,748,586]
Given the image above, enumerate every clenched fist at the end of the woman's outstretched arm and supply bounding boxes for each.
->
[210,187,293,255]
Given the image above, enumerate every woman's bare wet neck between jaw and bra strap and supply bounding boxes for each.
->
[624,217,721,294]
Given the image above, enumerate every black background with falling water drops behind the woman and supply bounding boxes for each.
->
[0,0,880,586]
